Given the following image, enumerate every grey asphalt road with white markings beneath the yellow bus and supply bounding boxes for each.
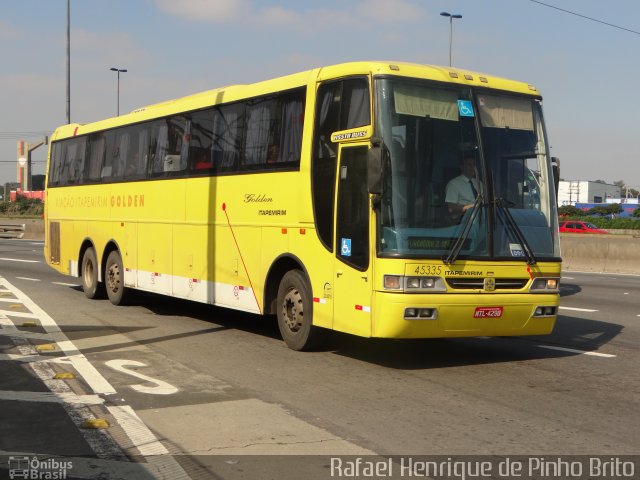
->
[0,240,640,480]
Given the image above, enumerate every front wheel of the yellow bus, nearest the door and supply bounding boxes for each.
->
[277,270,324,350]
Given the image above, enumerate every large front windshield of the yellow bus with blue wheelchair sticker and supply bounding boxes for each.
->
[375,78,559,263]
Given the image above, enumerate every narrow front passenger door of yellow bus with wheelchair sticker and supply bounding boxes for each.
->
[333,145,373,336]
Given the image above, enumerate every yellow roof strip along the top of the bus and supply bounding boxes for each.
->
[52,61,540,141]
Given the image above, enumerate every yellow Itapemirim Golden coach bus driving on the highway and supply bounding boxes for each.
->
[45,62,560,350]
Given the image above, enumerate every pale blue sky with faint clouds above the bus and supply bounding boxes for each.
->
[0,0,640,189]
